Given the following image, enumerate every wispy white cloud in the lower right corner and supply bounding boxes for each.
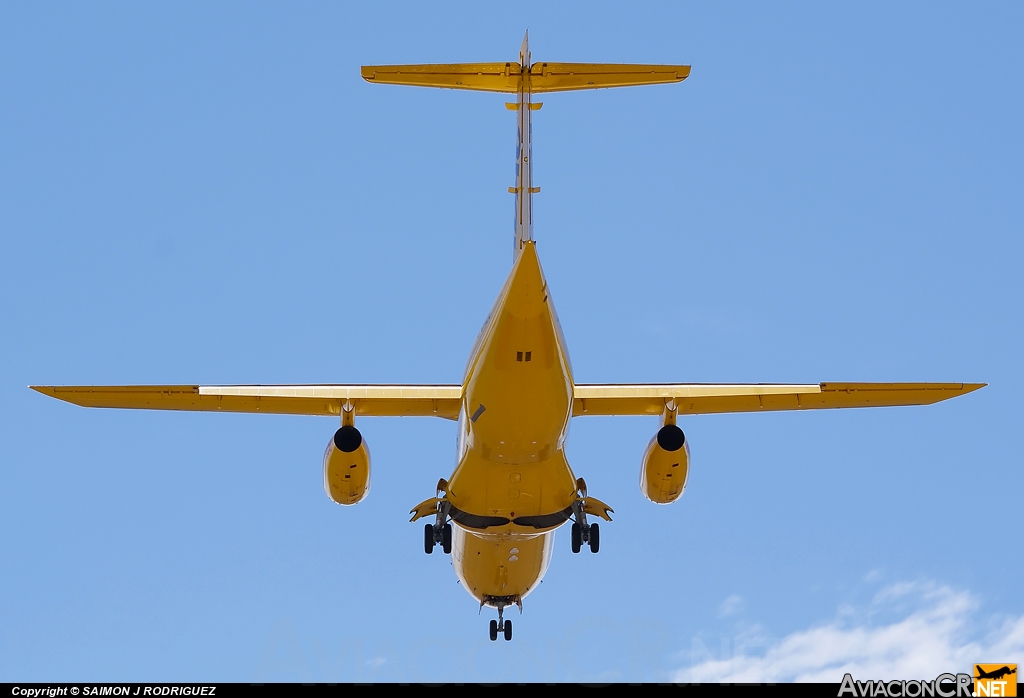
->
[673,582,1024,683]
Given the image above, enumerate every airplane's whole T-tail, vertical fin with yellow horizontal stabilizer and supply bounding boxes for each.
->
[362,32,690,261]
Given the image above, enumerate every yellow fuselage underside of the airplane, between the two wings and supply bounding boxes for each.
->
[446,242,580,606]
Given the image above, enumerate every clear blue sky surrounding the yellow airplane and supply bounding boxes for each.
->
[0,2,1024,681]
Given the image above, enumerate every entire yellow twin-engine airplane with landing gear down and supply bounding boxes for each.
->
[32,38,985,640]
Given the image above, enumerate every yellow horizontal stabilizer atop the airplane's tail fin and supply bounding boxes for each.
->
[361,62,690,94]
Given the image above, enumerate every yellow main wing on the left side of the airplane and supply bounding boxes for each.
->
[30,385,462,420]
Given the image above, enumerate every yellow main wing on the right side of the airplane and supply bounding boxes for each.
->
[572,383,986,417]
